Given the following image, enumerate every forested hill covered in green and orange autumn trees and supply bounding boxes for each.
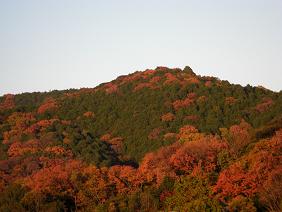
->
[0,66,282,212]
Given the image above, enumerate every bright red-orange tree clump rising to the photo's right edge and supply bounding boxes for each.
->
[214,130,282,202]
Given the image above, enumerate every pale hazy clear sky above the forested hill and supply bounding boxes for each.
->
[0,0,282,94]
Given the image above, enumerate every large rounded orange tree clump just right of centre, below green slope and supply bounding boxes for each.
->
[138,136,228,185]
